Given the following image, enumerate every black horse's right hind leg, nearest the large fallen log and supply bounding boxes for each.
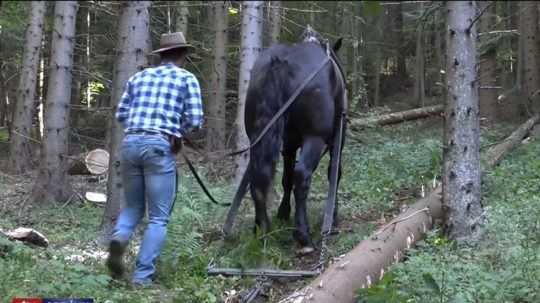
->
[293,137,325,252]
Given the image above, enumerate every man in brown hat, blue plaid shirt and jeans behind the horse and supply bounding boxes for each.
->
[106,32,203,285]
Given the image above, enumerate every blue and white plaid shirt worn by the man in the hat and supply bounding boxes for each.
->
[116,63,203,137]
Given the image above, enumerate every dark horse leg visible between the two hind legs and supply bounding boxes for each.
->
[277,146,297,221]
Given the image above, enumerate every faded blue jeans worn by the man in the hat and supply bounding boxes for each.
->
[112,134,177,283]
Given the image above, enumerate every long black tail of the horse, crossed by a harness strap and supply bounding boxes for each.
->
[249,57,290,201]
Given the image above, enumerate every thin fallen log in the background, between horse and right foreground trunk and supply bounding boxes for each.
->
[349,105,444,128]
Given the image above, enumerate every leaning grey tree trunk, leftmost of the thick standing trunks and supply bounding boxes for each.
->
[6,1,47,174]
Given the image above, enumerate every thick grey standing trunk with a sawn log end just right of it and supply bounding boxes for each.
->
[32,1,77,204]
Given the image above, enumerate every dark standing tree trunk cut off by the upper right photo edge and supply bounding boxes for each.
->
[519,1,540,113]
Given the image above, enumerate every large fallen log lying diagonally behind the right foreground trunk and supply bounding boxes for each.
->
[280,116,539,303]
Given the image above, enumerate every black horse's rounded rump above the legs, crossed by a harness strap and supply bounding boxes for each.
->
[245,43,341,142]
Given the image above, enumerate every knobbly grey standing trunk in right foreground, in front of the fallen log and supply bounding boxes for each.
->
[443,1,483,240]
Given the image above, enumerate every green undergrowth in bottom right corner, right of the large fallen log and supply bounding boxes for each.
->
[359,124,540,303]
